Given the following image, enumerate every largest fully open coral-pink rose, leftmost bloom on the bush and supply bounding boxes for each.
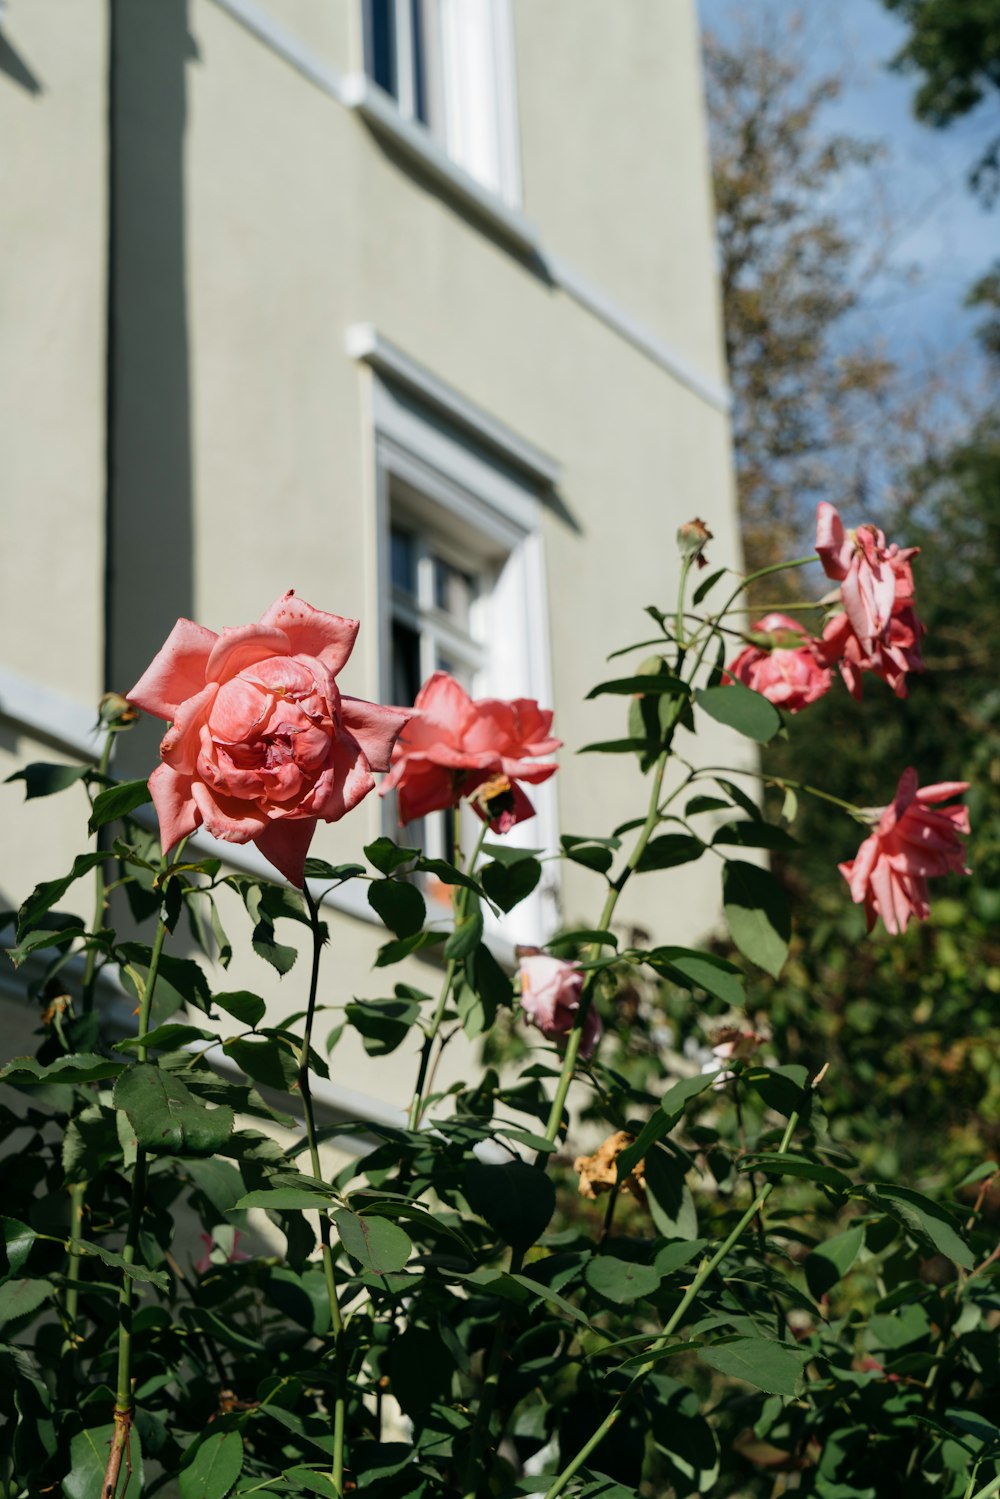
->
[127,591,408,886]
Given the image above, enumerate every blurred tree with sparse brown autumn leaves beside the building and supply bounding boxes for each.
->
[705,15,928,598]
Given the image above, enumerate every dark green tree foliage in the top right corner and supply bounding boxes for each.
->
[883,0,1000,204]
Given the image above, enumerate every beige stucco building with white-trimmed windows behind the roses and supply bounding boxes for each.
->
[0,0,739,1127]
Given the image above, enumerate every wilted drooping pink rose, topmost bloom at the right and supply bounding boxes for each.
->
[816,501,921,651]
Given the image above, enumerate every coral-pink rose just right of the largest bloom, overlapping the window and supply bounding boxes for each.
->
[381,672,561,833]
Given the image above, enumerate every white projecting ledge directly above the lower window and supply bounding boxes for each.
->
[346,322,562,489]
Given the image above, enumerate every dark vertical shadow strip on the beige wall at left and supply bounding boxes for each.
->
[106,0,198,773]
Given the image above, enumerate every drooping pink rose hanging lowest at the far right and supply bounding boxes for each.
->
[840,767,969,935]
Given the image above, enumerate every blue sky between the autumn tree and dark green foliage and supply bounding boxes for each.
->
[699,0,1000,374]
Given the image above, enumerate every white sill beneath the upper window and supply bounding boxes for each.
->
[343,73,541,258]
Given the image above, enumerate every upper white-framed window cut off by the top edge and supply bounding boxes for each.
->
[363,0,520,204]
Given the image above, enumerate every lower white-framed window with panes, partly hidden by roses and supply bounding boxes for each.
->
[373,370,558,943]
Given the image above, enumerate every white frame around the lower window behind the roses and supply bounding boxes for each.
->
[370,373,561,944]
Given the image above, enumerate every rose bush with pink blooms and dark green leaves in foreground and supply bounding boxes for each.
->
[0,516,1000,1499]
